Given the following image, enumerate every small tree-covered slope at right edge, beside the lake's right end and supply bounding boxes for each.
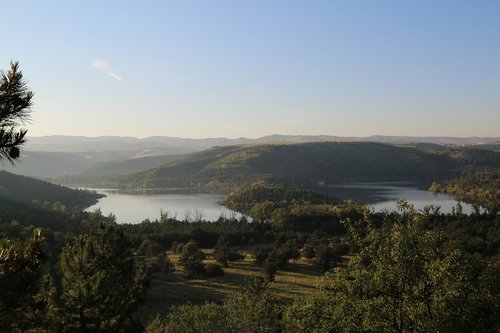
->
[429,169,500,211]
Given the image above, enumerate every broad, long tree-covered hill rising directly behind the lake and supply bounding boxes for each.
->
[99,142,500,193]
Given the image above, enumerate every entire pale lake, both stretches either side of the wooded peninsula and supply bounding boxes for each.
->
[87,182,473,223]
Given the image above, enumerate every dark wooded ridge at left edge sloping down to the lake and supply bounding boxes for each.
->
[0,170,102,208]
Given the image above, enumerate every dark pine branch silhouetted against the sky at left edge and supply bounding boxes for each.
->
[0,62,33,163]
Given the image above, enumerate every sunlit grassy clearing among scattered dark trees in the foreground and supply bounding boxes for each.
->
[140,249,322,320]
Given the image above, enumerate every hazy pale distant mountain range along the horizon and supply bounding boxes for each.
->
[0,135,500,181]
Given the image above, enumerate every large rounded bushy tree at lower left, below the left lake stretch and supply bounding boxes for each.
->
[61,224,148,332]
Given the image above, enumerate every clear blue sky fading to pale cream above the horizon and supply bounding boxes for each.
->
[0,0,500,138]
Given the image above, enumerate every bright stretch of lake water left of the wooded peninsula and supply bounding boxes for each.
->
[86,189,240,223]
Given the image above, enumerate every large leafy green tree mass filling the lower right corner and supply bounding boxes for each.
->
[324,205,499,332]
